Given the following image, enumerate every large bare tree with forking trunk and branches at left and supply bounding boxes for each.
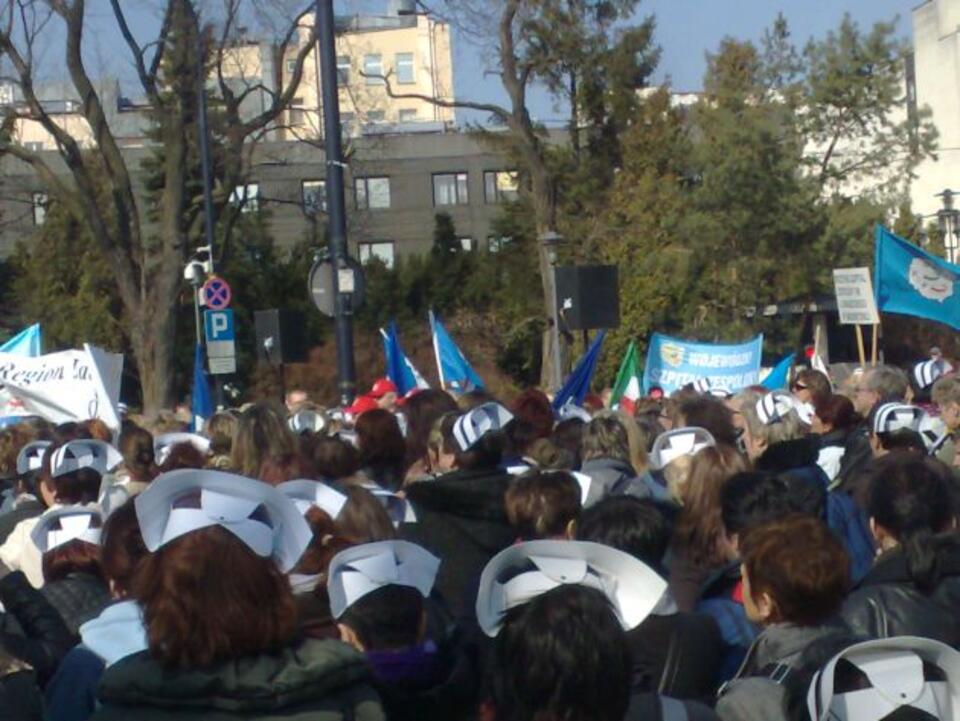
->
[0,0,316,413]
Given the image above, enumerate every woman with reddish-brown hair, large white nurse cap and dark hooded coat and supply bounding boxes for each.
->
[92,470,383,721]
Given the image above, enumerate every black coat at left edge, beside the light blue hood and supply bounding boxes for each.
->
[0,571,74,685]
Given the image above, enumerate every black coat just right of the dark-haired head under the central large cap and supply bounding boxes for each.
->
[627,611,723,701]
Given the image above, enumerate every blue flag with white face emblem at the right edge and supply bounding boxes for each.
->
[874,225,960,330]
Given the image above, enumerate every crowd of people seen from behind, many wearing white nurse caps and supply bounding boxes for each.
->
[0,356,960,721]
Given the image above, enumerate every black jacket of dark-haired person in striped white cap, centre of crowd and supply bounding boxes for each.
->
[400,470,515,617]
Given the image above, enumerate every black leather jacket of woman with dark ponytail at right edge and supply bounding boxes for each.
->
[842,536,960,647]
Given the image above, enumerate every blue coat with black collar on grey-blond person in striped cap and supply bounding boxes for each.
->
[757,436,874,582]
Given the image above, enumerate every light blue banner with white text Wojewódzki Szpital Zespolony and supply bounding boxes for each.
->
[643,333,763,393]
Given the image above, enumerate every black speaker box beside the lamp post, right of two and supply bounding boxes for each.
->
[557,265,620,330]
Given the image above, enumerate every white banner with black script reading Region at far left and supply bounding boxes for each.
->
[0,345,123,430]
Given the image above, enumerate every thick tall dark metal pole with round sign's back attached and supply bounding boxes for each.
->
[316,0,356,405]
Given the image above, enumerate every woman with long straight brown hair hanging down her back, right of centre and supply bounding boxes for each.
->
[669,445,750,611]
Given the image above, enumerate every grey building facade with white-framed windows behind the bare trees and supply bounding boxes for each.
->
[0,127,517,265]
